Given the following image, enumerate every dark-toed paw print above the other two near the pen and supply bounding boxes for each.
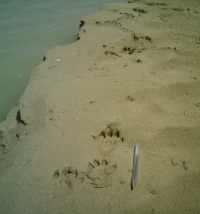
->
[93,123,124,155]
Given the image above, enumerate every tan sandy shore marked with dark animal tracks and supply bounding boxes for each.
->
[0,0,200,214]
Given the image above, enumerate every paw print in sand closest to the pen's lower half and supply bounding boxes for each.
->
[86,159,117,188]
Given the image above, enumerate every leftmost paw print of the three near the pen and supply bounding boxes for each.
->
[53,166,84,189]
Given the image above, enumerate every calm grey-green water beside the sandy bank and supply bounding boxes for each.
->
[0,0,120,121]
